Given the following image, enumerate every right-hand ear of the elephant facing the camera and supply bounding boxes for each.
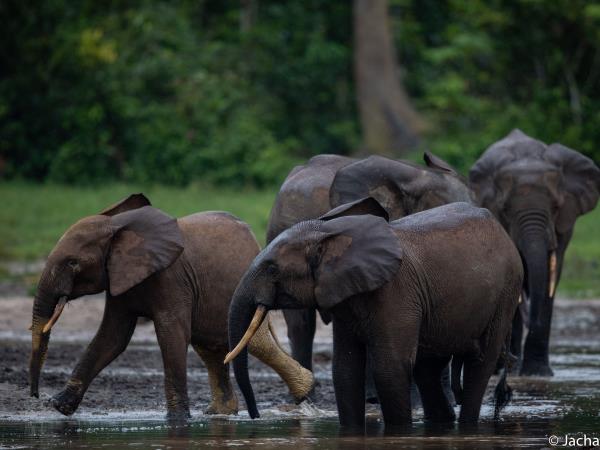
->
[548,143,600,233]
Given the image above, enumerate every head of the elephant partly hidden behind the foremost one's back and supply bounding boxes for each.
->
[330,152,475,220]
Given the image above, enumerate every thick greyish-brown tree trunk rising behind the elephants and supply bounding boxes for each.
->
[354,0,423,156]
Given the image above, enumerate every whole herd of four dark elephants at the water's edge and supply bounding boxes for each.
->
[30,130,600,427]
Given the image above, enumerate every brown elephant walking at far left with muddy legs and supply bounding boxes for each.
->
[30,194,313,419]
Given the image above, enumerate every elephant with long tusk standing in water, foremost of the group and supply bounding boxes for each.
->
[225,198,523,428]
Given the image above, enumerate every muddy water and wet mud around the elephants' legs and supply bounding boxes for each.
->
[0,302,600,449]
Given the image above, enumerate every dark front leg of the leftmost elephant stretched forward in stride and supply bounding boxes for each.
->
[50,299,137,416]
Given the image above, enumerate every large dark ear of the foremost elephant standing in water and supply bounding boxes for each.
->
[315,215,402,310]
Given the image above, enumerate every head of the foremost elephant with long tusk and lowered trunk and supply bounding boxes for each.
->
[225,198,402,418]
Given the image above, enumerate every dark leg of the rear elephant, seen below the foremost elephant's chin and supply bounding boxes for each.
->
[283,308,317,370]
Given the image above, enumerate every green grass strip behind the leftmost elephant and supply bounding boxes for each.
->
[0,182,276,261]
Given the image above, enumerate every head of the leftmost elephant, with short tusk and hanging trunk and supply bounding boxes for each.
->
[29,194,183,397]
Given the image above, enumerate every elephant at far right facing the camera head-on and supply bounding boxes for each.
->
[469,129,600,376]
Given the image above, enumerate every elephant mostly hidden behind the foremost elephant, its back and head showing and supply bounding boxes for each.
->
[267,152,474,370]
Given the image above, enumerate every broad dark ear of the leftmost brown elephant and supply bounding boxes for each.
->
[107,206,183,296]
